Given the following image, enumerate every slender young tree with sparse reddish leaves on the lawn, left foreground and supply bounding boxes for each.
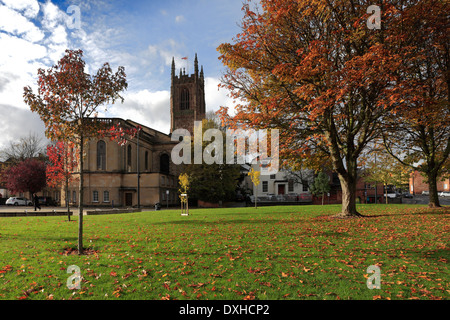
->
[24,50,127,254]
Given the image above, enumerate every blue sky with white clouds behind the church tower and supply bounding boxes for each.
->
[0,0,243,149]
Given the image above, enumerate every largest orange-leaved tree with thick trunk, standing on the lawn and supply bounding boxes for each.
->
[218,0,399,217]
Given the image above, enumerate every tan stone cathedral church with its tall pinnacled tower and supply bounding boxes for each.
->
[61,55,206,208]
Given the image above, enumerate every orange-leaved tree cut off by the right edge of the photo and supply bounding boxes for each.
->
[383,0,450,207]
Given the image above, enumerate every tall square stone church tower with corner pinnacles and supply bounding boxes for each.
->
[170,54,206,135]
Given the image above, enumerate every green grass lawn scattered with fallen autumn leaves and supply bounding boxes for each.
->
[0,205,450,300]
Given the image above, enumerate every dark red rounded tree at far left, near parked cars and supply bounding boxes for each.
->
[4,159,46,195]
